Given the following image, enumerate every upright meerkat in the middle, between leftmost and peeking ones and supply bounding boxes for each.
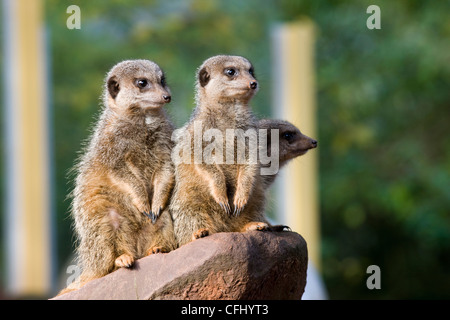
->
[169,55,268,245]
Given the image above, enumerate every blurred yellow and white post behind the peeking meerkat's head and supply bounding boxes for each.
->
[272,21,320,268]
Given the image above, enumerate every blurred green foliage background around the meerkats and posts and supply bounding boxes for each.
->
[0,0,450,299]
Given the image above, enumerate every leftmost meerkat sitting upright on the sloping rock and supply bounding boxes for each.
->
[67,60,176,290]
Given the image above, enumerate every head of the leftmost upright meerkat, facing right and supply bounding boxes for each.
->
[104,60,171,112]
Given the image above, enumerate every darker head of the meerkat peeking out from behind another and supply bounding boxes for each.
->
[258,119,317,166]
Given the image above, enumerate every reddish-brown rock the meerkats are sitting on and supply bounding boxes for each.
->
[51,231,308,300]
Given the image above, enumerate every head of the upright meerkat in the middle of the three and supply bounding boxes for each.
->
[196,55,258,102]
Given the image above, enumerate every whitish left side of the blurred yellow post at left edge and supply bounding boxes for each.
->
[3,0,24,294]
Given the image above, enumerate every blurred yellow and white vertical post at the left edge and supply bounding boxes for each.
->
[2,0,52,296]
